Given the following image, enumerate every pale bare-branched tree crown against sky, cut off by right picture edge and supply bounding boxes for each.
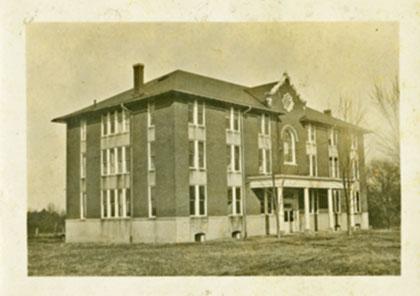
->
[370,78,400,166]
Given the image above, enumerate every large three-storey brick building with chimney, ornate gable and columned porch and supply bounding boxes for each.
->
[53,64,368,242]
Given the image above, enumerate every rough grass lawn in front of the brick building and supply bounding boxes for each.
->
[28,230,400,276]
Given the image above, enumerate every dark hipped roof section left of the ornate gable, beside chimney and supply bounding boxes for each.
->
[53,70,280,122]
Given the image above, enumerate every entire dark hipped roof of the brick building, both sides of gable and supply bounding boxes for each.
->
[53,70,369,132]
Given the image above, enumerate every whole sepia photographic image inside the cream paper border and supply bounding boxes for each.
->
[25,21,402,277]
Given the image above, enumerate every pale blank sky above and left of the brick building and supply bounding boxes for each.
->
[26,22,399,209]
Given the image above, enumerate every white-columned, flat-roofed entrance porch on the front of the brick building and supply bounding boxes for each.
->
[249,175,345,234]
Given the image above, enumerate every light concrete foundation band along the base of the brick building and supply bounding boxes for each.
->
[66,213,369,243]
